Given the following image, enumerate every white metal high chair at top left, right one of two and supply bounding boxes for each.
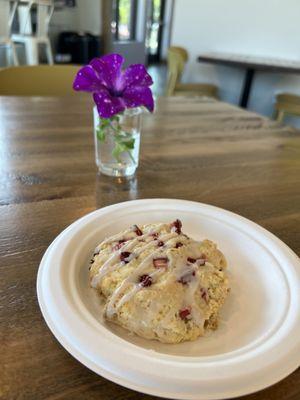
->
[12,0,54,65]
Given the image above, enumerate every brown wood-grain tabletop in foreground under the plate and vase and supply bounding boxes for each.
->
[0,95,300,400]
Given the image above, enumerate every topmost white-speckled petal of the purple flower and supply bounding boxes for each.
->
[90,54,124,90]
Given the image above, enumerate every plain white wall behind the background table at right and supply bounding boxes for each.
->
[171,0,300,119]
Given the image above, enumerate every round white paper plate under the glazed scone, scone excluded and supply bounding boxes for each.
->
[37,199,300,400]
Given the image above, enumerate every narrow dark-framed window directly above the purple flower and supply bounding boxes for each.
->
[111,0,137,41]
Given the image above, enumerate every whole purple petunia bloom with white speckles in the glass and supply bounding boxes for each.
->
[73,54,154,118]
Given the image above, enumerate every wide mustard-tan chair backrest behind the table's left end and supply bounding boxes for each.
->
[0,65,80,96]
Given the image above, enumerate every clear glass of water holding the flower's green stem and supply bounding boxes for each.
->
[94,107,143,176]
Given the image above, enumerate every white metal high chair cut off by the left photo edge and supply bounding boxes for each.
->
[0,0,19,65]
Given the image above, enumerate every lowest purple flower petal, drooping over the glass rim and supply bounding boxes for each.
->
[93,89,125,118]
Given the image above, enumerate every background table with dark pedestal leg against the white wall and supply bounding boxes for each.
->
[198,52,300,108]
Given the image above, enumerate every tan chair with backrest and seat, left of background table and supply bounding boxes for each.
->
[166,46,218,98]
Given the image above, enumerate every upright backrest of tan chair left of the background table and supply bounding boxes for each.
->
[166,46,188,96]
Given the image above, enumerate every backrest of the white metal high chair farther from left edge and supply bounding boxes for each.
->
[16,0,54,37]
